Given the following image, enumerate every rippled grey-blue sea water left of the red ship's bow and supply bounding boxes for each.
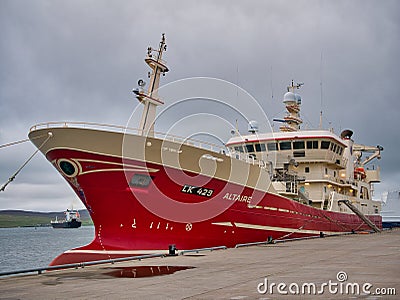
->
[0,226,94,272]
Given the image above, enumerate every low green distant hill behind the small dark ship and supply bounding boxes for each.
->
[0,209,93,228]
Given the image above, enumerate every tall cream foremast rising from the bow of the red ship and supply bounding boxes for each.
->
[133,33,169,136]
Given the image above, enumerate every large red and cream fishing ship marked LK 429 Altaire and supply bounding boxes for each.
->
[29,35,383,265]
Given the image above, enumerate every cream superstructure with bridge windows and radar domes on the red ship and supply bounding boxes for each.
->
[227,84,383,215]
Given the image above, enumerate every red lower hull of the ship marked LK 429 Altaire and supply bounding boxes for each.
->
[41,145,381,265]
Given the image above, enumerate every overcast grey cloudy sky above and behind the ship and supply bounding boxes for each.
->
[0,0,400,211]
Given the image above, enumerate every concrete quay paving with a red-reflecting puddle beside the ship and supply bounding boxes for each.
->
[0,229,400,300]
